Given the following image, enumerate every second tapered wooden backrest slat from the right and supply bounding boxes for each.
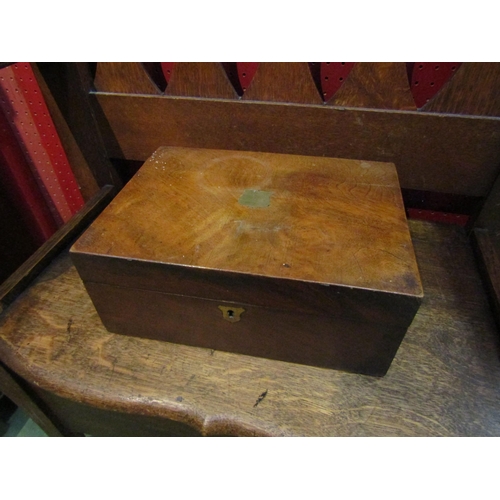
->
[327,62,417,111]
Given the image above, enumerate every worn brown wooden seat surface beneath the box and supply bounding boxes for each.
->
[0,221,500,436]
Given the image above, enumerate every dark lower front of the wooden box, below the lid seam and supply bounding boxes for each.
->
[86,283,406,376]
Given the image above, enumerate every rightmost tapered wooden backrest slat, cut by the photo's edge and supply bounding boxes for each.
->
[422,62,500,116]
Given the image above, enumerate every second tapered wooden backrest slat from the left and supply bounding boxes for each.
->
[165,62,238,99]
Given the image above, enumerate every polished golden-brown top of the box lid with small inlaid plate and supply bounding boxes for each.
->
[72,147,422,320]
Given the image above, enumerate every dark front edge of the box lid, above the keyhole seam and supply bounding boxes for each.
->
[72,254,420,328]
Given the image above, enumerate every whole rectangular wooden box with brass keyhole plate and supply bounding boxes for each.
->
[71,147,422,376]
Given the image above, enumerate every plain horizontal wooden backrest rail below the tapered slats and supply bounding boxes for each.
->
[95,93,500,196]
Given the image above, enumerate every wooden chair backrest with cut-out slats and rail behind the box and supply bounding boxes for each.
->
[82,63,500,205]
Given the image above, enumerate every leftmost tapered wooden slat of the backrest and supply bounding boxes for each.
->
[94,62,161,94]
